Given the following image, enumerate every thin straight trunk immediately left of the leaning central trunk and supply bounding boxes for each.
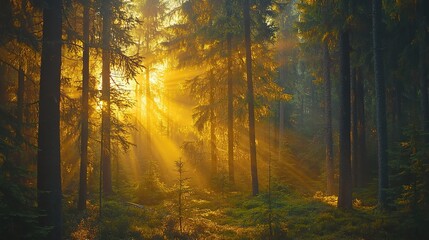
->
[226,1,235,183]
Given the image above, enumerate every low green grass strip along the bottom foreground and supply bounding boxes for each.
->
[66,185,423,240]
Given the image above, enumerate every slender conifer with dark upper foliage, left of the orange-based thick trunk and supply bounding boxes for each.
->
[297,0,338,194]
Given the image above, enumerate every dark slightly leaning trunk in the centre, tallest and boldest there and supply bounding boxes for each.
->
[243,0,259,196]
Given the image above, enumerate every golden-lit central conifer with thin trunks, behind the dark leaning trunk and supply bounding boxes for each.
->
[169,1,284,188]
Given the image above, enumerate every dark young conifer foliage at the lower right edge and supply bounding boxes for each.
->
[390,127,429,238]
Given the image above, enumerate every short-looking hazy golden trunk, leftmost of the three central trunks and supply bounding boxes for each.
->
[209,74,217,177]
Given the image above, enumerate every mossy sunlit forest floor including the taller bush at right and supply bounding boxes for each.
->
[65,130,428,240]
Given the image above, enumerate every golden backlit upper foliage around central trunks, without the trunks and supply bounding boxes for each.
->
[169,1,284,130]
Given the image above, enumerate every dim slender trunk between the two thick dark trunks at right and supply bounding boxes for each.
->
[356,67,369,187]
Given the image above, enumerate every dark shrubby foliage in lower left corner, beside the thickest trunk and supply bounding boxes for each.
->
[0,106,49,239]
